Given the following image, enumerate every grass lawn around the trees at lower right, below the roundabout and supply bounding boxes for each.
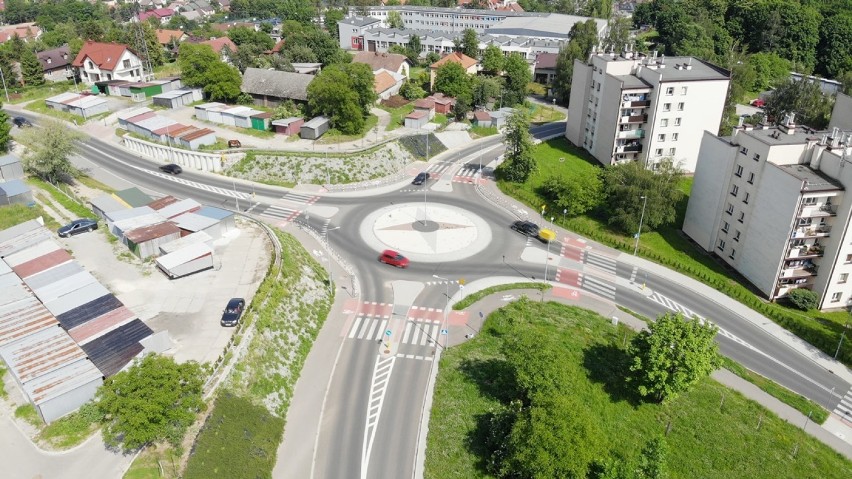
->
[425,301,852,479]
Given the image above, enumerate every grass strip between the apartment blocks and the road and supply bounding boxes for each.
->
[498,138,852,365]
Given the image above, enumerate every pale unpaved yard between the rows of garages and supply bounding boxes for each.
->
[59,220,271,362]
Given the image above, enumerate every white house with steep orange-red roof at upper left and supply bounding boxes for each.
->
[71,41,143,85]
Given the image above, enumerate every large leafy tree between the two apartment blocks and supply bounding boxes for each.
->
[602,159,683,234]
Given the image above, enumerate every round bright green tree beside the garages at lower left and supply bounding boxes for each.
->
[97,354,204,450]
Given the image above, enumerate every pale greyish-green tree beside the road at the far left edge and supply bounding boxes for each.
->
[18,120,80,184]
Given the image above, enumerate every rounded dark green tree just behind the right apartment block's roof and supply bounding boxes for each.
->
[764,79,834,130]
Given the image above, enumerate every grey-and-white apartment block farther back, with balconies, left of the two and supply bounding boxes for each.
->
[565,53,730,172]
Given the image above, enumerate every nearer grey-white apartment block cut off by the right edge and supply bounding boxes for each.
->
[683,104,852,309]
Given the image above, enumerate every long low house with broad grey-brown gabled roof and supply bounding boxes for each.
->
[241,68,314,106]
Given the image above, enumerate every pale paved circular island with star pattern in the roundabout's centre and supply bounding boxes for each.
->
[360,203,491,263]
